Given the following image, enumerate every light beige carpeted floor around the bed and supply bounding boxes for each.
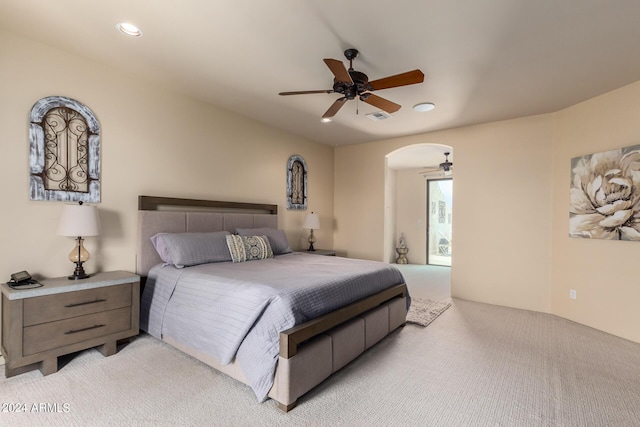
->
[0,299,640,426]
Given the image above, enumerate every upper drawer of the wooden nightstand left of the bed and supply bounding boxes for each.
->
[24,283,131,327]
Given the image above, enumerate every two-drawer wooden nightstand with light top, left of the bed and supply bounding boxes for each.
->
[1,271,140,378]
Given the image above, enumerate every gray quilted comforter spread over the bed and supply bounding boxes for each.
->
[140,253,403,401]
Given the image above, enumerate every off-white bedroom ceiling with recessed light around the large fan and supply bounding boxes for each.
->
[0,0,640,154]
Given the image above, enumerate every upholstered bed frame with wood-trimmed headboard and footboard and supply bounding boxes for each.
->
[136,196,407,412]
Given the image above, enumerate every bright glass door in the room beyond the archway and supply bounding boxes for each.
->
[426,178,453,267]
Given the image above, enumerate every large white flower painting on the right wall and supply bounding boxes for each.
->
[569,145,640,241]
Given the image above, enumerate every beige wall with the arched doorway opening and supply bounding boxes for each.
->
[334,115,553,312]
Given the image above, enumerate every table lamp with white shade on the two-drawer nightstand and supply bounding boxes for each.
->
[57,202,100,280]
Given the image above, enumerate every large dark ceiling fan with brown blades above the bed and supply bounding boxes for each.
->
[279,49,424,119]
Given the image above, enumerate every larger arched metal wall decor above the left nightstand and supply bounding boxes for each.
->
[29,96,100,203]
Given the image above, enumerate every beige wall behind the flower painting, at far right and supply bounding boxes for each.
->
[551,82,640,342]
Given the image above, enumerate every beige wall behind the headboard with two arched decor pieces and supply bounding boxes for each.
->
[0,32,333,280]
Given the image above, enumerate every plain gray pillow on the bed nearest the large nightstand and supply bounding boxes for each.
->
[151,231,231,268]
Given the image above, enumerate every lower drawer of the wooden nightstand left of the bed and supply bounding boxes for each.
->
[23,307,131,356]
